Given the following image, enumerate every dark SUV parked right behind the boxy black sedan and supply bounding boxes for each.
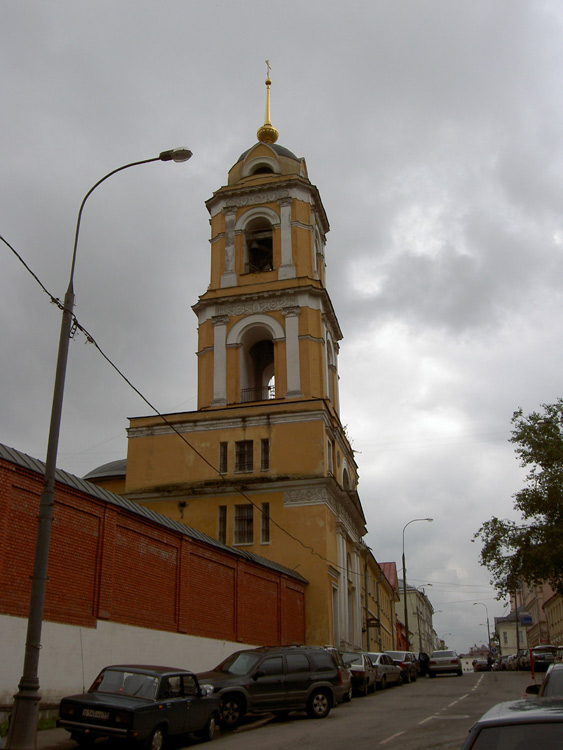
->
[197,646,343,729]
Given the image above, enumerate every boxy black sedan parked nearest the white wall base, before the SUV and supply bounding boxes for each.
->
[57,664,221,750]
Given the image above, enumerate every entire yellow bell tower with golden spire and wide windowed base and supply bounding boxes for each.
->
[94,80,366,651]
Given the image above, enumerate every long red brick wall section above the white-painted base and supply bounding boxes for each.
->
[0,460,305,645]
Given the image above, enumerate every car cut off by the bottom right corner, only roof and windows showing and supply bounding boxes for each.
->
[461,698,563,750]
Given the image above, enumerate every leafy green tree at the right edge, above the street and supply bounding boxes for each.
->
[474,399,563,598]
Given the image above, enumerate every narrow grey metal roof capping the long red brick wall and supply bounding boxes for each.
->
[0,443,308,583]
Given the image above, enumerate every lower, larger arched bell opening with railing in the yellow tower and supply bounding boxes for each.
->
[240,326,276,402]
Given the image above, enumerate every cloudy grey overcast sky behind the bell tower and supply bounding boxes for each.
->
[0,0,563,651]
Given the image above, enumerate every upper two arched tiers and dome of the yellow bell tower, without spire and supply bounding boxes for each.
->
[193,142,342,413]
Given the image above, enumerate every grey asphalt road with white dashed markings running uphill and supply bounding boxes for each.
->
[38,672,543,750]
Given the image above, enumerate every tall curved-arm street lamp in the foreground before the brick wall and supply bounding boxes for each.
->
[5,148,192,750]
